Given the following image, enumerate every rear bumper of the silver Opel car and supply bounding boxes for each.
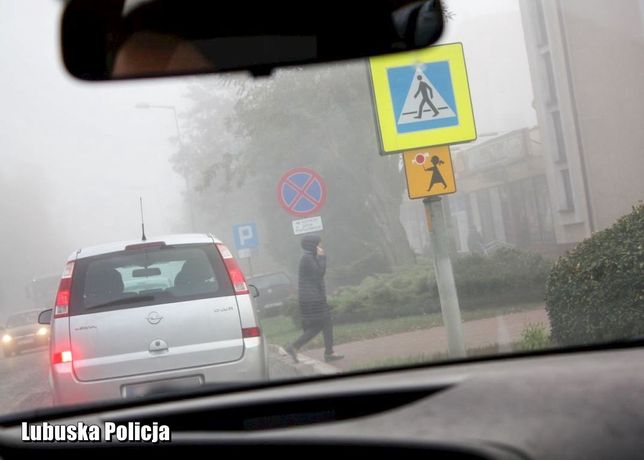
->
[50,338,268,405]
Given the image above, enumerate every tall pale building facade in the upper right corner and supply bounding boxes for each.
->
[521,0,644,244]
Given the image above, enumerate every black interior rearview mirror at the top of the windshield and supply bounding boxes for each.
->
[62,0,443,80]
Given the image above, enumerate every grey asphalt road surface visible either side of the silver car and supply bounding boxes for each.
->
[0,349,299,415]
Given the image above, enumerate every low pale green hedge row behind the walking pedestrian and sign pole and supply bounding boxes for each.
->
[285,249,551,324]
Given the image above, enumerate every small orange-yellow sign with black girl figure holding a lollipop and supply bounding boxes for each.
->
[403,146,456,200]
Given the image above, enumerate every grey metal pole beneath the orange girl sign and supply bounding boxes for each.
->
[423,197,466,358]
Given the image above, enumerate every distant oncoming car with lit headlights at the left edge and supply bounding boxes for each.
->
[1,310,49,356]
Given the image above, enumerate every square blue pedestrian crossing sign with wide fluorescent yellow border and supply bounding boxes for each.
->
[369,43,476,153]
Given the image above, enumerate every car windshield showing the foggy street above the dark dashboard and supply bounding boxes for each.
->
[0,0,644,415]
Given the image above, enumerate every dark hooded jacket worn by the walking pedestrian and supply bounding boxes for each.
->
[298,235,331,319]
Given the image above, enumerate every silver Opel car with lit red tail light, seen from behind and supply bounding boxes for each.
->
[39,235,268,404]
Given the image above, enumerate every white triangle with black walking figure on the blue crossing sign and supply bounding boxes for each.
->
[398,68,456,125]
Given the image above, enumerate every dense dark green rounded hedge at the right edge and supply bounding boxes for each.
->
[546,204,644,345]
